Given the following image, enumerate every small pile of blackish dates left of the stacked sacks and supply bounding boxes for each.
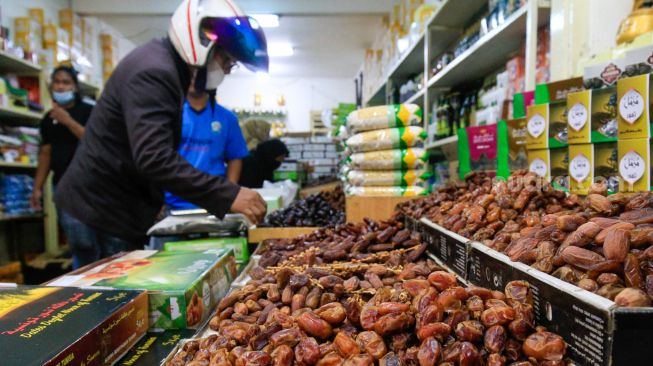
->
[261,189,345,227]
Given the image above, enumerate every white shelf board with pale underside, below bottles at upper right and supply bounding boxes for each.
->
[427,6,550,95]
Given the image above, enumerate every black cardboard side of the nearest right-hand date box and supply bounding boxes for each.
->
[467,242,653,366]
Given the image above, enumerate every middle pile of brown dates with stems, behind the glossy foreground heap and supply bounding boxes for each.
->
[257,219,426,268]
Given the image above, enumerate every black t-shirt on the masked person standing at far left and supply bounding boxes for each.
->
[41,100,93,184]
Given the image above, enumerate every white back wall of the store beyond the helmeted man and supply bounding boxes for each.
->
[218,73,354,132]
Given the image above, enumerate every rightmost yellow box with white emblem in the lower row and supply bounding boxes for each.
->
[617,139,653,192]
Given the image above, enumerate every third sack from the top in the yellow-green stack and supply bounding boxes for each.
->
[348,148,429,170]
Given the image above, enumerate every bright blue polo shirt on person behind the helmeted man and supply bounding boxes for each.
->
[165,101,249,210]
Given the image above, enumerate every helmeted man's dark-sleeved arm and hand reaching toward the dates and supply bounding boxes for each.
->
[122,69,266,223]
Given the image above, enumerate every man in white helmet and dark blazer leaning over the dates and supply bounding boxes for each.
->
[55,0,268,259]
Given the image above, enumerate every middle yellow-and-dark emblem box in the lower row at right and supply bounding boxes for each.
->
[569,142,619,195]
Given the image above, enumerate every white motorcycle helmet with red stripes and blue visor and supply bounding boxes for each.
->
[168,0,269,85]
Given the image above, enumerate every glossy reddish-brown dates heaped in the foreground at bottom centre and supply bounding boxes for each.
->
[167,262,566,366]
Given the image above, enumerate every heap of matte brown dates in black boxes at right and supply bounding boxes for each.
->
[397,172,653,306]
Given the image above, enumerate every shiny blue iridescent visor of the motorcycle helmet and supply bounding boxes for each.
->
[200,16,269,72]
